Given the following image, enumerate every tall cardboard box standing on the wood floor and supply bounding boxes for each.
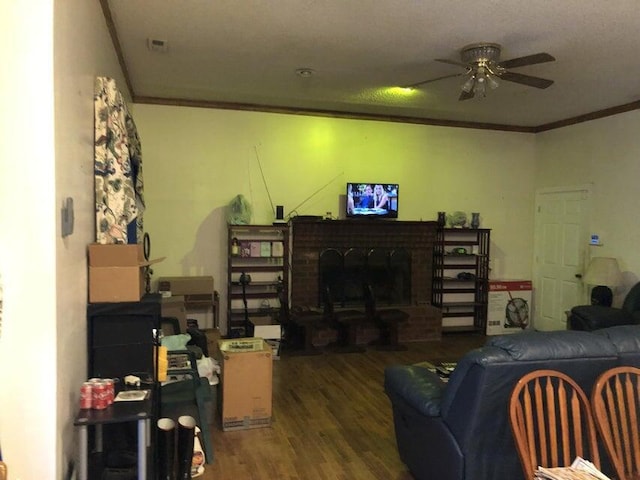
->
[218,338,273,432]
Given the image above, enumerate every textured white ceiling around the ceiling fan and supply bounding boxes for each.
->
[101,0,640,127]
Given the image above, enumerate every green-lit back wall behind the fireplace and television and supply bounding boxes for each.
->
[133,105,535,326]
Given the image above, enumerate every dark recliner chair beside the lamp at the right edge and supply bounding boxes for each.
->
[568,283,640,331]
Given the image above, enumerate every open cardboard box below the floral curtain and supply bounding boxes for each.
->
[89,243,164,303]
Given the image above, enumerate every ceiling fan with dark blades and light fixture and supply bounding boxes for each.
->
[407,43,555,100]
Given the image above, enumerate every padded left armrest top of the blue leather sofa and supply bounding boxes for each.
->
[384,365,446,417]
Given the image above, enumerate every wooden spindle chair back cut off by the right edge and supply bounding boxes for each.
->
[591,366,640,480]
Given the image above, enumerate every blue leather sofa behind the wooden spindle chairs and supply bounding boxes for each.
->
[384,326,640,480]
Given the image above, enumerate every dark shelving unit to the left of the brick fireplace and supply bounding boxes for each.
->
[227,225,289,336]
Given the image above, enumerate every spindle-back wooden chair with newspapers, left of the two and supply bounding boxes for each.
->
[509,370,600,479]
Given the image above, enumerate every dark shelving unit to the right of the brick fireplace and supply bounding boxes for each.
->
[432,228,491,332]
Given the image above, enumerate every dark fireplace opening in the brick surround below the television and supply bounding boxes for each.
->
[318,248,411,307]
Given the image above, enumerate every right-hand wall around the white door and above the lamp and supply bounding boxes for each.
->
[536,110,640,305]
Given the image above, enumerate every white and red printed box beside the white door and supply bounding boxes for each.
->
[487,280,533,335]
